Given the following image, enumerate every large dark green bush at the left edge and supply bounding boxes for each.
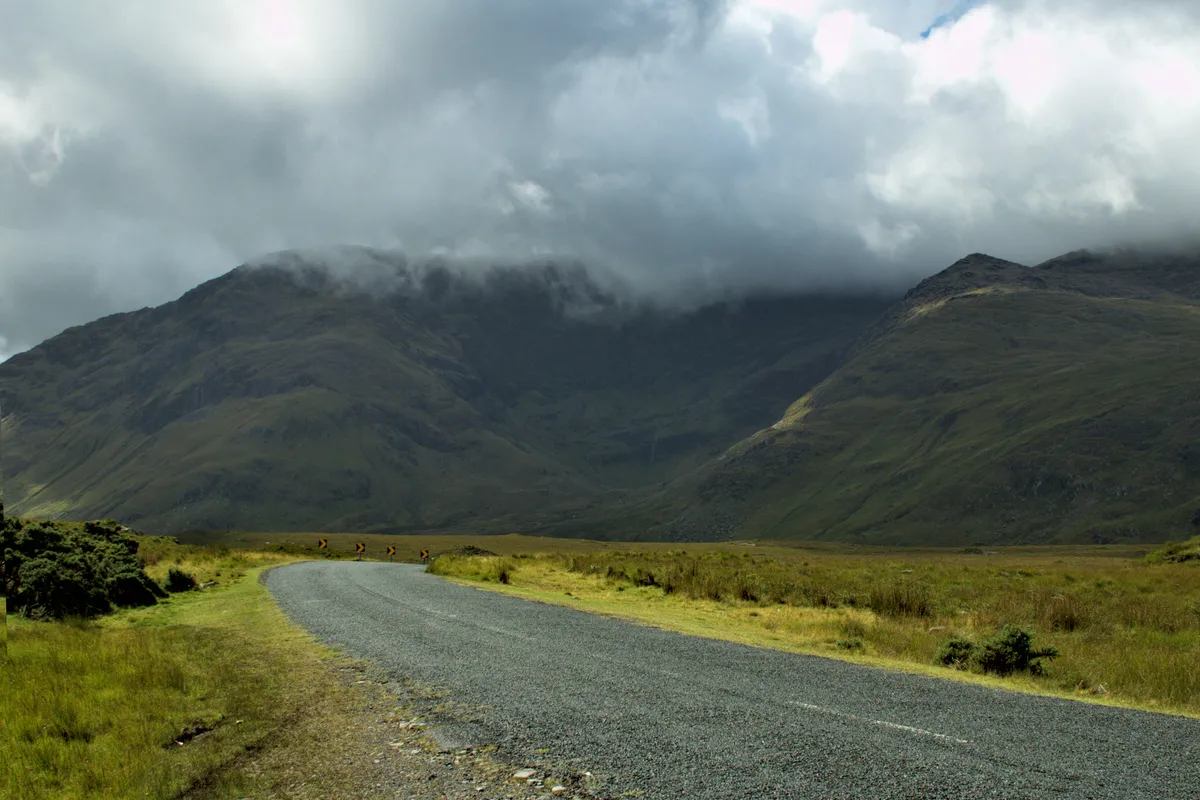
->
[0,510,164,619]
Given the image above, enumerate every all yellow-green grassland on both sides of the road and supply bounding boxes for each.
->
[7,534,1200,800]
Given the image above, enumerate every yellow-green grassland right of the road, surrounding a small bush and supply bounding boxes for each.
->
[430,545,1200,716]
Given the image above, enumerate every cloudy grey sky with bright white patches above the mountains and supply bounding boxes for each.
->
[0,0,1200,359]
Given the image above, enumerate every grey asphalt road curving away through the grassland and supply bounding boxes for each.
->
[266,561,1200,800]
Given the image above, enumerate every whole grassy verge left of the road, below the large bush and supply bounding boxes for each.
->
[0,540,374,800]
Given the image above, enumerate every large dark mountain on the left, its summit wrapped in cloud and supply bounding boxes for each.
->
[0,248,888,533]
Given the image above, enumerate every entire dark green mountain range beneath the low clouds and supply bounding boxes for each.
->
[0,244,1200,546]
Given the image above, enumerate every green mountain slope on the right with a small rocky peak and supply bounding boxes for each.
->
[652,252,1200,545]
